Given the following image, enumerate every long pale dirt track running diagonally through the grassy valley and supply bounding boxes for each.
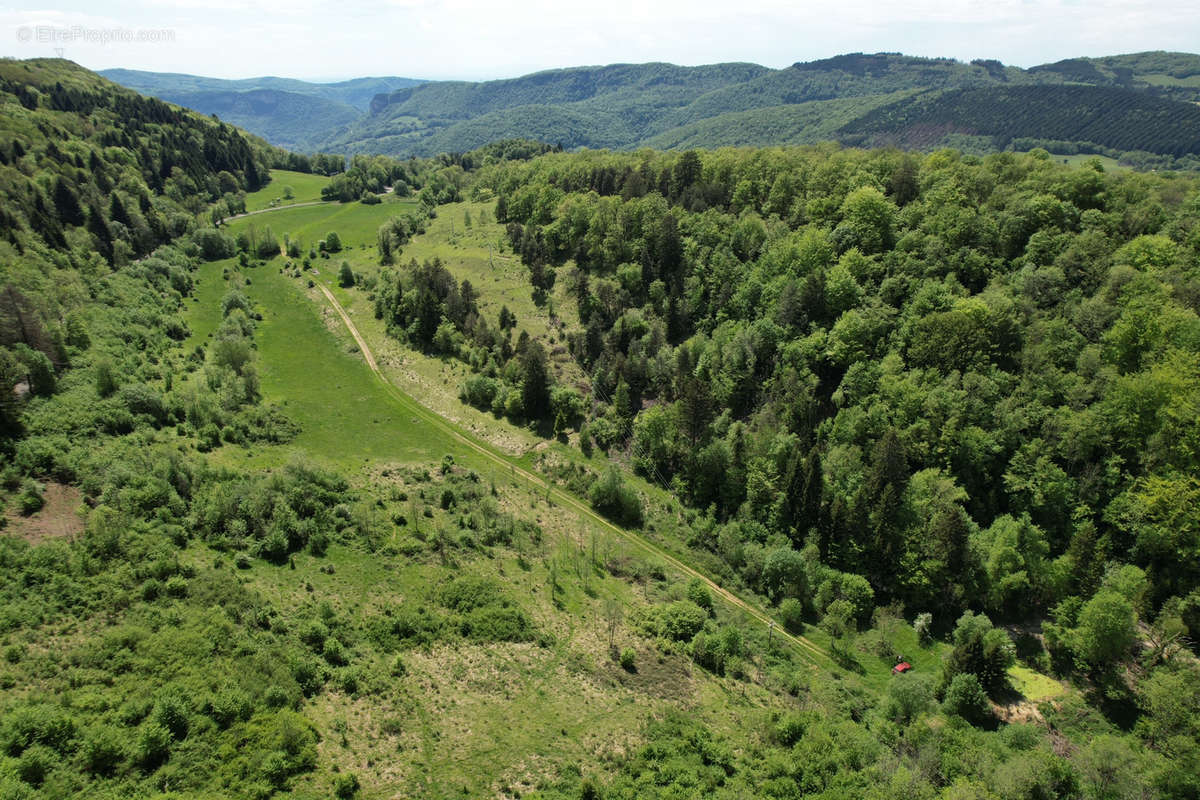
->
[317,283,834,667]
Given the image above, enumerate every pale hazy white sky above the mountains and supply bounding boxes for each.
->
[0,0,1200,80]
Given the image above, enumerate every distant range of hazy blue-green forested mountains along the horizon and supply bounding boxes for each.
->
[102,52,1200,158]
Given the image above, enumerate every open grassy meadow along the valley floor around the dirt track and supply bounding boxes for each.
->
[166,185,1089,798]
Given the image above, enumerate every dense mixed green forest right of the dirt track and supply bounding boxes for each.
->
[478,149,1200,661]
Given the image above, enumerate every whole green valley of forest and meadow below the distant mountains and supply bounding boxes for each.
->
[0,60,1200,800]
